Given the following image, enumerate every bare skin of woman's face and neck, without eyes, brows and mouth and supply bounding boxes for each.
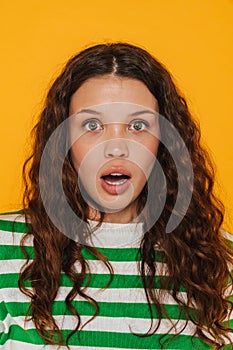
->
[70,75,159,223]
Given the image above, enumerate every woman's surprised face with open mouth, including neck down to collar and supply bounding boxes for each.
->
[70,75,159,222]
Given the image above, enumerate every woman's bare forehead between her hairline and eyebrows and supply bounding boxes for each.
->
[70,75,158,114]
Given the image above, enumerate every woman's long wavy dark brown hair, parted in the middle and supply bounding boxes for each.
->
[19,43,233,349]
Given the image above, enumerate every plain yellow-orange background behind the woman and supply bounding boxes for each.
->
[0,0,233,231]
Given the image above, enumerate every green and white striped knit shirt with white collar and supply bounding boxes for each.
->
[0,214,233,350]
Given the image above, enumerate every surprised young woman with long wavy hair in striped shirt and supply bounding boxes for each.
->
[0,43,233,350]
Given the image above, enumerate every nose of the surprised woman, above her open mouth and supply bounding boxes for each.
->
[104,138,129,158]
